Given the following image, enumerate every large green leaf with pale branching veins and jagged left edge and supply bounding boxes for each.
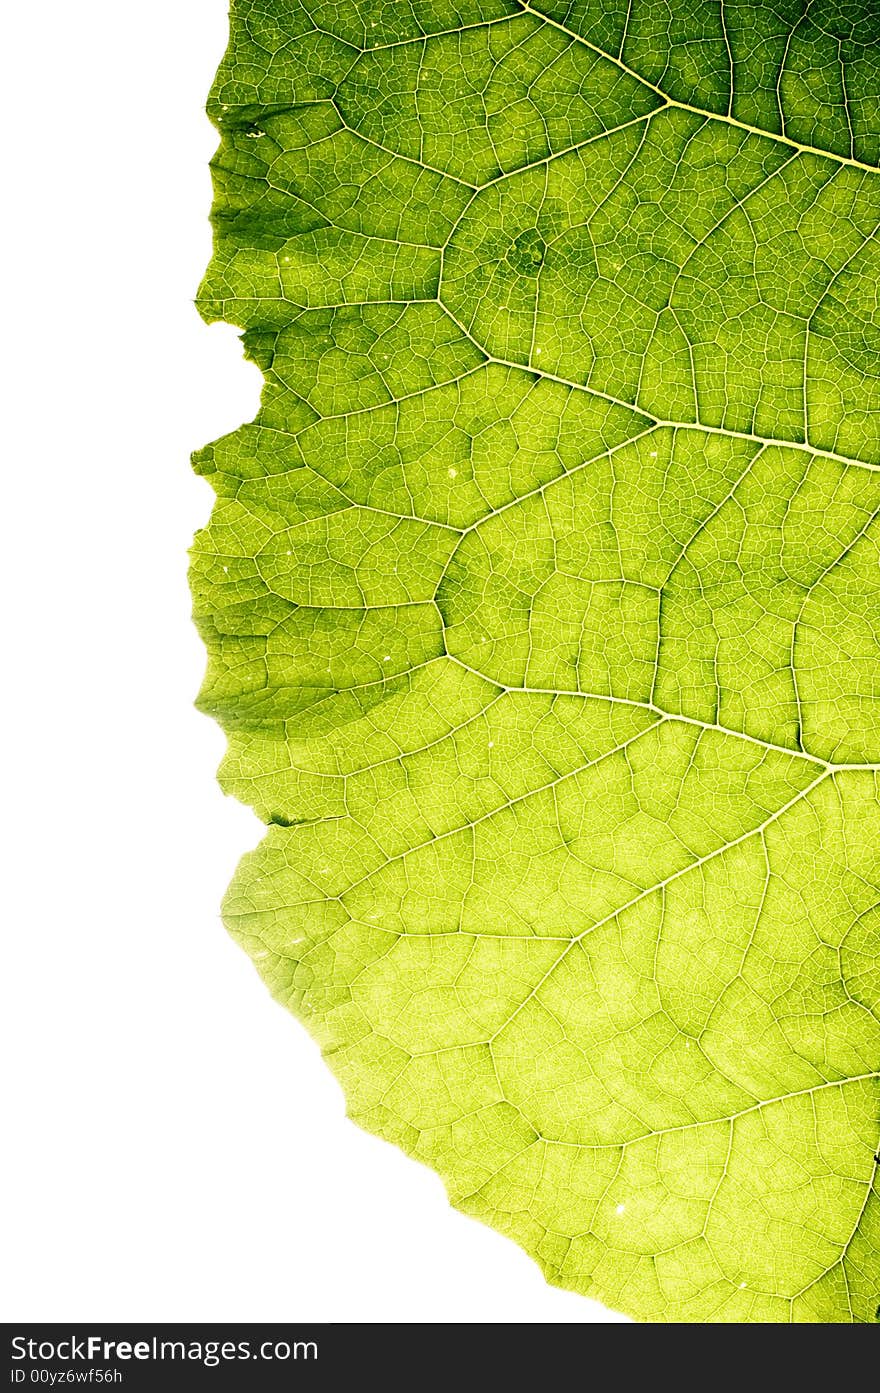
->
[192,0,880,1322]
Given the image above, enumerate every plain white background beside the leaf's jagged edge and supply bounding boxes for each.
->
[0,0,622,1322]
